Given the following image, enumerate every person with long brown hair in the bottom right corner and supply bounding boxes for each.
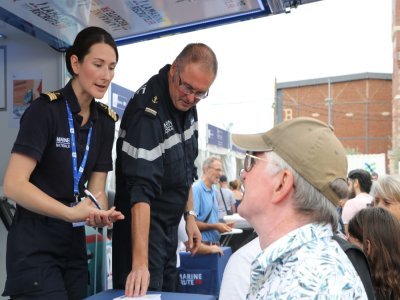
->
[348,207,400,300]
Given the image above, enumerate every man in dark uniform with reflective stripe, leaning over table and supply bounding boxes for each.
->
[113,44,217,296]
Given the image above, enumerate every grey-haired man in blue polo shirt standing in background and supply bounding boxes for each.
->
[192,156,232,246]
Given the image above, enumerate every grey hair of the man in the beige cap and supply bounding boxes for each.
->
[267,152,345,232]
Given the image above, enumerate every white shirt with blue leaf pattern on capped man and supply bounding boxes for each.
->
[247,223,368,299]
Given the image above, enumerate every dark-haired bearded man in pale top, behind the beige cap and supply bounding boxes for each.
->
[342,169,373,234]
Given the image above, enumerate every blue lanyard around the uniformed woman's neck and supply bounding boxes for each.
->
[65,100,93,202]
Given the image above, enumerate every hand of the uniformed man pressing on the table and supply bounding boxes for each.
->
[125,266,150,297]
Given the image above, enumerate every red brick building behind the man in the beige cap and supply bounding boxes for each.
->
[275,73,393,172]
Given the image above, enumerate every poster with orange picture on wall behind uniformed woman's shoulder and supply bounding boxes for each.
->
[8,72,43,128]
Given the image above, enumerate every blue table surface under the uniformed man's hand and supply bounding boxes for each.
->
[86,290,216,300]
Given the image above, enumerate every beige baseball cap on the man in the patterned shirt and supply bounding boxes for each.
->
[232,117,347,205]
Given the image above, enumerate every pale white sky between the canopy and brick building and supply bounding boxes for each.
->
[113,0,393,133]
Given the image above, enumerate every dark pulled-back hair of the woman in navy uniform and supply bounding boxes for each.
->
[65,26,118,77]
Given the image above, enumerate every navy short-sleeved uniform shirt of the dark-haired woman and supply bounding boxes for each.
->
[12,83,115,202]
